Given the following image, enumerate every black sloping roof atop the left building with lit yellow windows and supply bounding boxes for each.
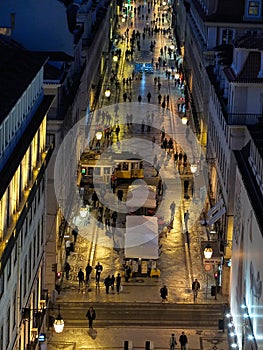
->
[0,46,47,123]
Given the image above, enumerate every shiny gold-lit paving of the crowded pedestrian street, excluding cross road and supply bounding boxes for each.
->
[48,3,231,350]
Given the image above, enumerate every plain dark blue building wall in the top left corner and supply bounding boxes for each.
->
[0,0,74,56]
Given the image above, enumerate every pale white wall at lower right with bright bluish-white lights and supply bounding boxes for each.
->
[230,171,263,349]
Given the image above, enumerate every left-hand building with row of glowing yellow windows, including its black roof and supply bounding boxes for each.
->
[0,47,53,350]
